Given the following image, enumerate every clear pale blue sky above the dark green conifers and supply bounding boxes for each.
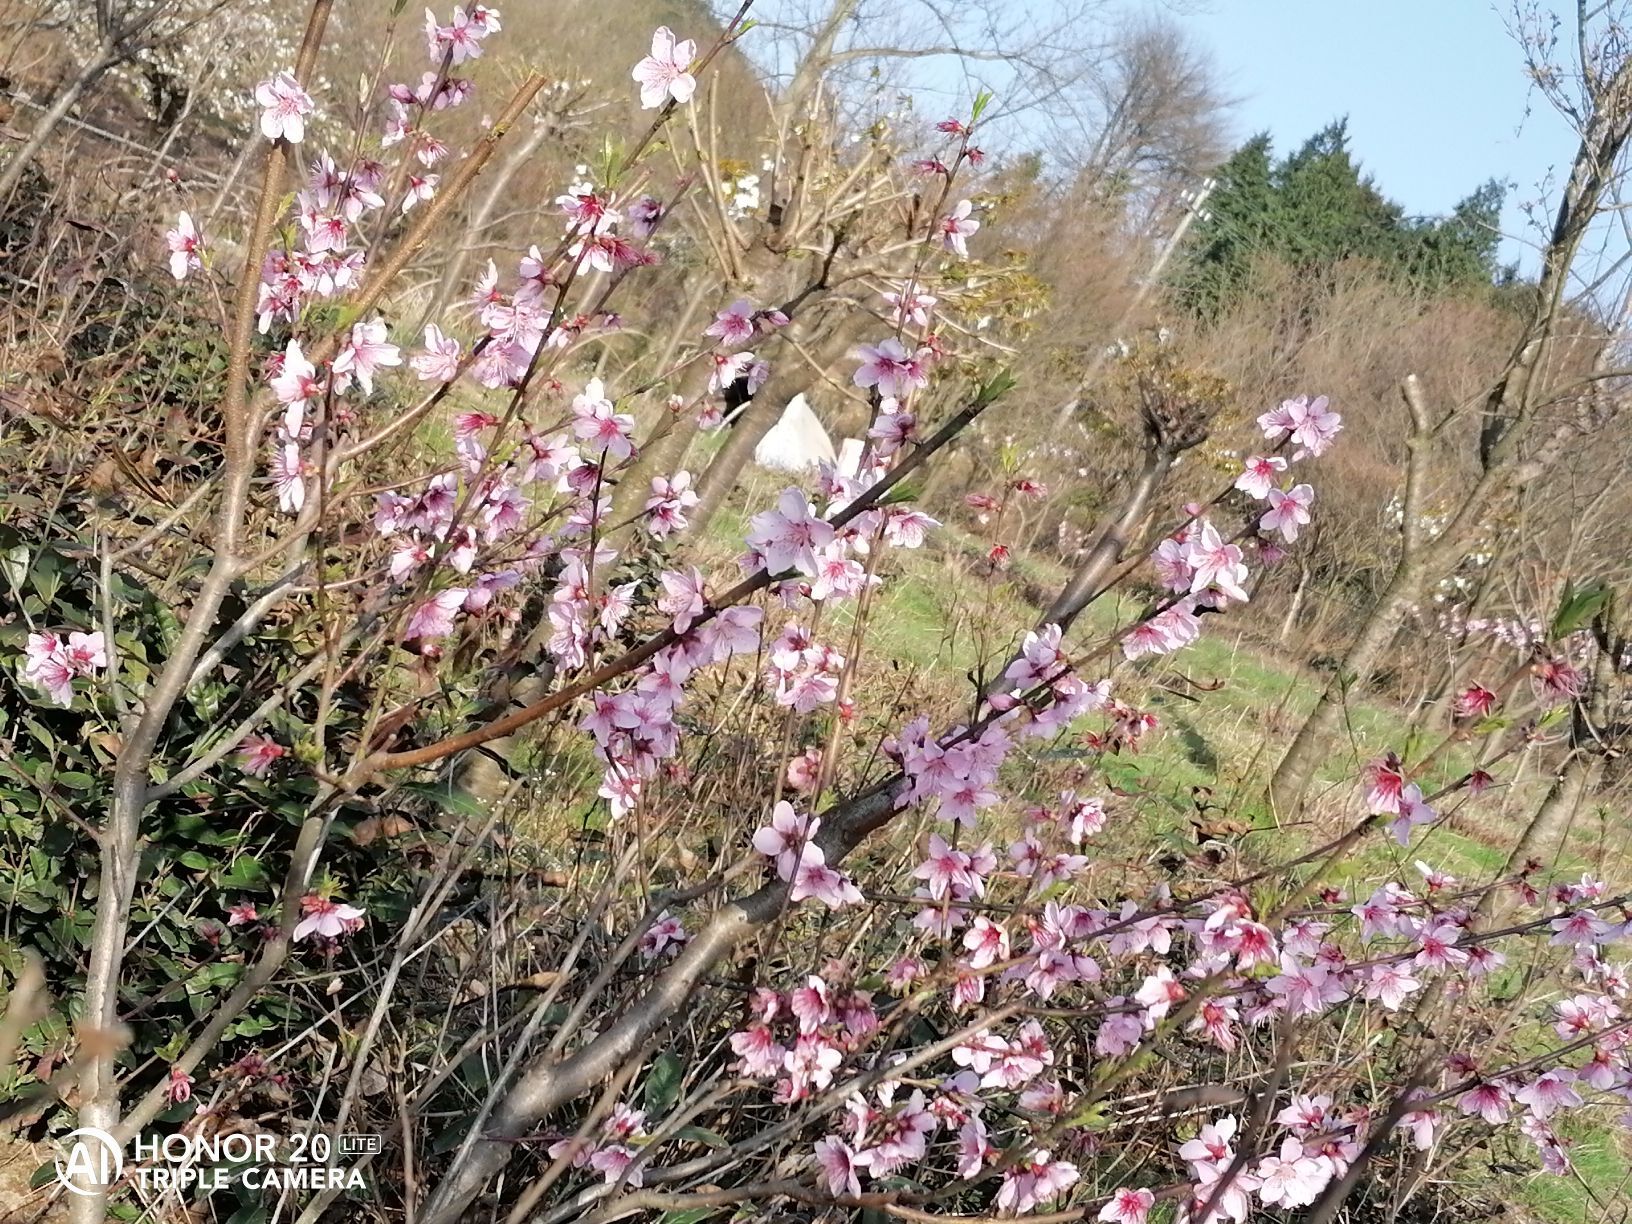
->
[1169,0,1575,271]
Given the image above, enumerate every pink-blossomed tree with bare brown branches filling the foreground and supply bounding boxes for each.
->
[0,0,1632,1224]
